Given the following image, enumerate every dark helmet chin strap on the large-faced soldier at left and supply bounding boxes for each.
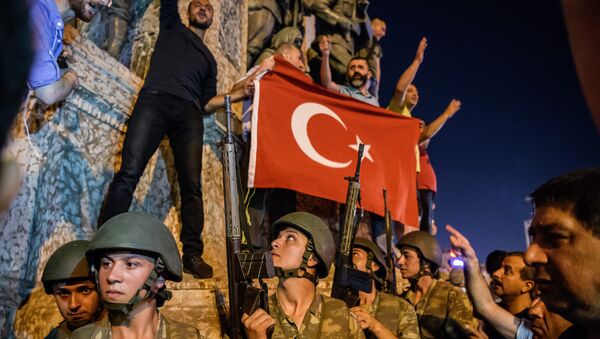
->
[92,257,173,315]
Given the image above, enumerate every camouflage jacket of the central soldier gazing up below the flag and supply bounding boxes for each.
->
[269,294,364,339]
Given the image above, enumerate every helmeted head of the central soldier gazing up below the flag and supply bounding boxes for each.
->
[271,212,335,283]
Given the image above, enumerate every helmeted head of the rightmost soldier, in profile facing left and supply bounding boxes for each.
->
[396,231,442,282]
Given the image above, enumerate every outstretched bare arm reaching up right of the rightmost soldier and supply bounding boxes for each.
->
[446,225,520,338]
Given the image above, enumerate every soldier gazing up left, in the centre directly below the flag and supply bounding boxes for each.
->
[242,212,364,339]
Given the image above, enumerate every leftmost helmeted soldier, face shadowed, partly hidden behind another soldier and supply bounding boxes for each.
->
[42,240,104,339]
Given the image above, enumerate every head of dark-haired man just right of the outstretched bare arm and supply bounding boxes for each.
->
[492,252,535,301]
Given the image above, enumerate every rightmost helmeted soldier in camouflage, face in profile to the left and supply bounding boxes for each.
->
[397,231,478,339]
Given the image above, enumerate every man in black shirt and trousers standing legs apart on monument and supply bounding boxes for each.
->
[99,0,217,279]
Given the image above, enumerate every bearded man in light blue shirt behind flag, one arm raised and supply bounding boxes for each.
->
[319,35,379,106]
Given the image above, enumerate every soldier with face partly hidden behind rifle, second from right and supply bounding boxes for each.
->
[352,238,420,339]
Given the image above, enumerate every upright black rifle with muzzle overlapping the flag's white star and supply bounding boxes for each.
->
[331,144,373,307]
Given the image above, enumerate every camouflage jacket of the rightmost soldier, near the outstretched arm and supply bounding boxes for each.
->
[402,279,478,339]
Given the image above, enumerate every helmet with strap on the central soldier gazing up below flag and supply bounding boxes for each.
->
[272,212,335,278]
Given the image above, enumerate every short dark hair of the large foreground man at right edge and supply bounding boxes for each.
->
[529,167,600,238]
